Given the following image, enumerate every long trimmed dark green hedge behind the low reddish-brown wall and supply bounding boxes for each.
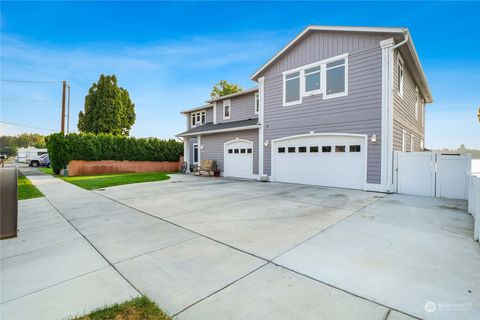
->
[47,133,183,174]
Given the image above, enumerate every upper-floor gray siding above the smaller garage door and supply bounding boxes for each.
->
[217,92,258,123]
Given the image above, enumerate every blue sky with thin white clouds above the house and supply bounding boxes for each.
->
[0,1,480,148]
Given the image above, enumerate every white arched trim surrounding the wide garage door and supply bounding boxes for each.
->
[270,133,368,190]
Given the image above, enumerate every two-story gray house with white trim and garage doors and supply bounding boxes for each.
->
[178,26,432,192]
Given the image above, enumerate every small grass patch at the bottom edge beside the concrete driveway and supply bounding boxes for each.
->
[73,297,172,320]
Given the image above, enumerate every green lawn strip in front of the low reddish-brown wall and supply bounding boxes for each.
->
[39,168,171,190]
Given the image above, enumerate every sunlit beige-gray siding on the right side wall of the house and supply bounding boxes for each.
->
[393,50,425,152]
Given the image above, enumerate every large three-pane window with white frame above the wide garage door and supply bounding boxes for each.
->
[283,53,348,106]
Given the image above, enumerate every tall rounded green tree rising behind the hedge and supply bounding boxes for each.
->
[78,74,135,136]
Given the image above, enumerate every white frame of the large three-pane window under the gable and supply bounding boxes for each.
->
[282,52,349,107]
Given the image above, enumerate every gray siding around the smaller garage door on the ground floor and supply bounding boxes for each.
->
[201,129,258,174]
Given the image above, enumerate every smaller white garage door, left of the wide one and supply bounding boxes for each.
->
[223,139,253,179]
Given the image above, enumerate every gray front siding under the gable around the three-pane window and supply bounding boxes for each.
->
[264,32,388,183]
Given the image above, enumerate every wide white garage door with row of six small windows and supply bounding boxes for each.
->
[272,134,367,189]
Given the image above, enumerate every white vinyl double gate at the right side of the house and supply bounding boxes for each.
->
[395,151,471,199]
